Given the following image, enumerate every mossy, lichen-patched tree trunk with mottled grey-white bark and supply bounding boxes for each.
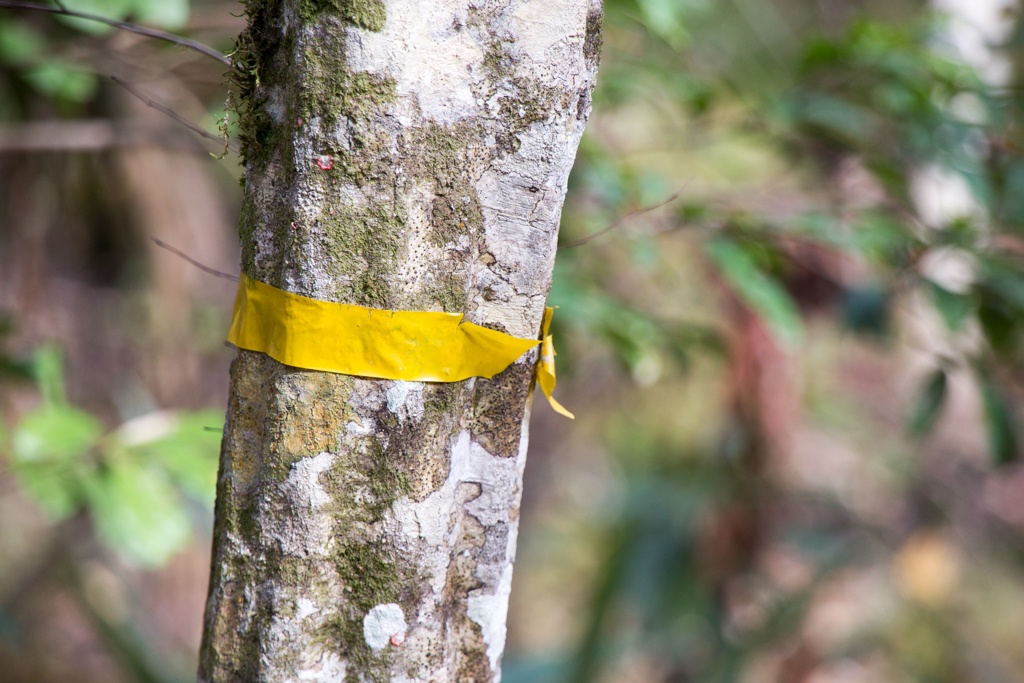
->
[199,0,602,683]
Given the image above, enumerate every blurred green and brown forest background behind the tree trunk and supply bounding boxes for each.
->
[0,0,1024,683]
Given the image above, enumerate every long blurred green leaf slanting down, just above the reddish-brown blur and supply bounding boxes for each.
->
[706,238,804,348]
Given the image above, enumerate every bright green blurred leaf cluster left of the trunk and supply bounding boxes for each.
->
[4,347,222,567]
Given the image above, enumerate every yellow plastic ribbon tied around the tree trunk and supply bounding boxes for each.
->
[227,274,572,417]
